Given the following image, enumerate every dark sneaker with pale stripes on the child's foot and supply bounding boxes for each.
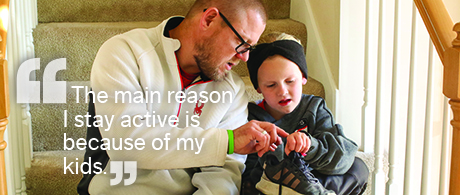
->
[256,152,335,195]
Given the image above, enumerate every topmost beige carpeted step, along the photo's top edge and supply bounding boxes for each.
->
[37,0,291,23]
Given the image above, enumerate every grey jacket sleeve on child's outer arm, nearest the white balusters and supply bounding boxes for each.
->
[305,97,358,175]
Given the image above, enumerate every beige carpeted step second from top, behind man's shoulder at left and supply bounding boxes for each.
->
[33,22,160,81]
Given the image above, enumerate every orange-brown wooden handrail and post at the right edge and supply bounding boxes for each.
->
[414,0,460,194]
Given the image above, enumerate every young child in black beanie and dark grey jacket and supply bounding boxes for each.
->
[242,33,369,194]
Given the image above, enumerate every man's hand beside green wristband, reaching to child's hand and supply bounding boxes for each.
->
[233,120,289,156]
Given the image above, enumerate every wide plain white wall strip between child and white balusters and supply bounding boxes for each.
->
[336,0,366,146]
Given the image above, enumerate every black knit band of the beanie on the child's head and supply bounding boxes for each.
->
[247,40,308,89]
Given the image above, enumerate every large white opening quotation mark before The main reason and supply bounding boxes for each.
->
[16,58,66,103]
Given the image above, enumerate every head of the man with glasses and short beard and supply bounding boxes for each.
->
[181,0,267,81]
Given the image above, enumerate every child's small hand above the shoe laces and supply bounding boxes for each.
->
[284,132,311,156]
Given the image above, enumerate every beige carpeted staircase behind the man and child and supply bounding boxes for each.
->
[26,0,324,195]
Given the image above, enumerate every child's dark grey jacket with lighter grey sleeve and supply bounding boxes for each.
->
[243,94,358,182]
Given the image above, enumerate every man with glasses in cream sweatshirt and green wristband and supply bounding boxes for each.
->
[78,0,287,194]
